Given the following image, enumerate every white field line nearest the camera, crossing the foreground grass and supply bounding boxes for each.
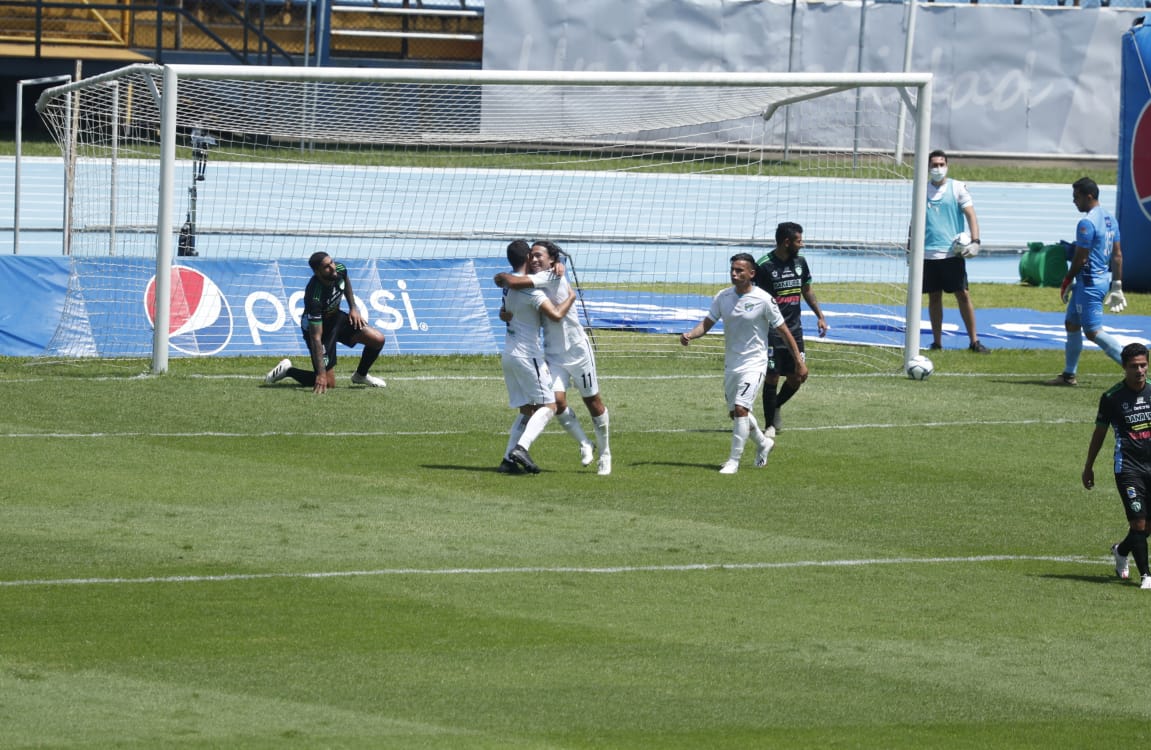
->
[0,554,1110,588]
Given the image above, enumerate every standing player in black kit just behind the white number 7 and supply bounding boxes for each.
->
[755,221,828,437]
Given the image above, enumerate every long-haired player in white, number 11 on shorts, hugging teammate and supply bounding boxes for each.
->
[495,240,611,476]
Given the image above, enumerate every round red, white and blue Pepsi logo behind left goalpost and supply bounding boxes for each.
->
[144,266,233,357]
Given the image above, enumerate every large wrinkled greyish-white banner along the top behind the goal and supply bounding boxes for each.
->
[483,0,1142,158]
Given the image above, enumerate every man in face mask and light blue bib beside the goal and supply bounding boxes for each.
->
[923,150,988,354]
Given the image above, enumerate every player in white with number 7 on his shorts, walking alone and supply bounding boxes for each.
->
[679,253,807,474]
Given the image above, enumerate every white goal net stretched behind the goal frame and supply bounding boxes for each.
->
[38,64,931,372]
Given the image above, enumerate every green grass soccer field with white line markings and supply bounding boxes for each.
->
[0,350,1151,749]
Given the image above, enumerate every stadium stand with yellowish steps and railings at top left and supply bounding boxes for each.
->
[0,0,483,67]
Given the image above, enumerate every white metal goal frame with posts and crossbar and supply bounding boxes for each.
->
[37,64,932,374]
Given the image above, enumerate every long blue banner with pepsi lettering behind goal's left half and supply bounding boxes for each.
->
[0,258,506,357]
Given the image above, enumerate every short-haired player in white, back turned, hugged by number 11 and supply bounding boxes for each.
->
[498,239,572,474]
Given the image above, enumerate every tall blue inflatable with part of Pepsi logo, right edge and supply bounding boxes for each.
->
[1115,17,1151,292]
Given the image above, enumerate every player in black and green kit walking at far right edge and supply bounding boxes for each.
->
[1083,343,1151,590]
